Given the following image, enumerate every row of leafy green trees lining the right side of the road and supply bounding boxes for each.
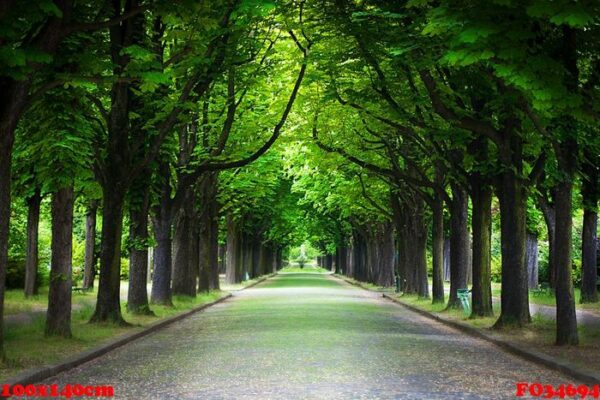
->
[284,0,600,345]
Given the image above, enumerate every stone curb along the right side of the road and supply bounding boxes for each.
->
[332,274,600,385]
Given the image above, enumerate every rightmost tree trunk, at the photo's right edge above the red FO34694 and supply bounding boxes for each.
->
[581,150,600,303]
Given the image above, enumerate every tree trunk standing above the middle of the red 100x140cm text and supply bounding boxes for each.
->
[45,186,75,337]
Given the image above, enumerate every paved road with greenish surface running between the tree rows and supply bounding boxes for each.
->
[45,274,572,399]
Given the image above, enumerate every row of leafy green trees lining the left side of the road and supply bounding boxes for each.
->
[0,0,312,360]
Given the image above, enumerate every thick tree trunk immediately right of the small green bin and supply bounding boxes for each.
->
[471,182,494,318]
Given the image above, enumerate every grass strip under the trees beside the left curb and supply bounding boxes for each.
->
[0,291,226,382]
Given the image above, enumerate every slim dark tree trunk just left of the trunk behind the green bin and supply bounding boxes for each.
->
[431,198,444,303]
